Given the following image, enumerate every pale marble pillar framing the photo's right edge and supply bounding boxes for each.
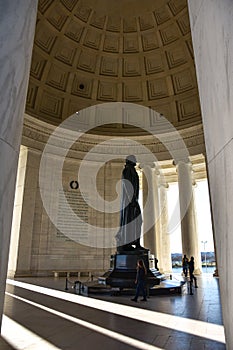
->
[188,0,233,349]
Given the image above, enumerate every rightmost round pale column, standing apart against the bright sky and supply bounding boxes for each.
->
[176,160,201,274]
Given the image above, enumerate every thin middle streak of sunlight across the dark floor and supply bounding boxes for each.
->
[6,292,162,350]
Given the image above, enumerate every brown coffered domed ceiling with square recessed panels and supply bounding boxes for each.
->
[26,0,201,131]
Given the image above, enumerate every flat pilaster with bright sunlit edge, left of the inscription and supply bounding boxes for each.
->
[8,146,41,277]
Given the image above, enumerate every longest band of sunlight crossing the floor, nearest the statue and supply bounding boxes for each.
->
[7,279,225,343]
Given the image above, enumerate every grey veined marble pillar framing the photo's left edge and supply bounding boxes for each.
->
[0,0,37,323]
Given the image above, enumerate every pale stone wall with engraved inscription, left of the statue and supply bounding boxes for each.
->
[8,147,120,277]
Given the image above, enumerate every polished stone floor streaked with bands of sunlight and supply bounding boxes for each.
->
[0,273,226,350]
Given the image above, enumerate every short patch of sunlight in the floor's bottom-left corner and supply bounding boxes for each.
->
[1,315,60,350]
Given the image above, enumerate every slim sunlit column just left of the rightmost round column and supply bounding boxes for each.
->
[159,178,172,273]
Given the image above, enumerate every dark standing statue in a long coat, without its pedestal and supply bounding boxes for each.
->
[116,155,145,252]
